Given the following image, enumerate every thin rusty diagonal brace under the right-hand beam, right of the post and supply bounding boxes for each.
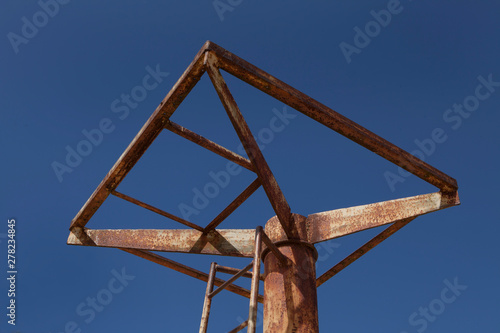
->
[316,217,415,287]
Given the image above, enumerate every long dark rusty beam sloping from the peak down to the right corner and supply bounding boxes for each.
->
[206,42,458,192]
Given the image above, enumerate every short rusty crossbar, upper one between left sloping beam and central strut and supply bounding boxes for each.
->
[165,120,254,172]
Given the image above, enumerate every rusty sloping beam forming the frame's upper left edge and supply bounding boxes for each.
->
[70,42,211,229]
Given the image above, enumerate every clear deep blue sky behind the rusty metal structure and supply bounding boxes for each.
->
[0,0,500,333]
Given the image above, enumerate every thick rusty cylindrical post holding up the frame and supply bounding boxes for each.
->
[262,214,319,333]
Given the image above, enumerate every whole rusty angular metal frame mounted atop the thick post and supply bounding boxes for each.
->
[68,41,460,332]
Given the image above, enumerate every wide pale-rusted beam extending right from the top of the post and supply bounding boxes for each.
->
[307,192,460,243]
